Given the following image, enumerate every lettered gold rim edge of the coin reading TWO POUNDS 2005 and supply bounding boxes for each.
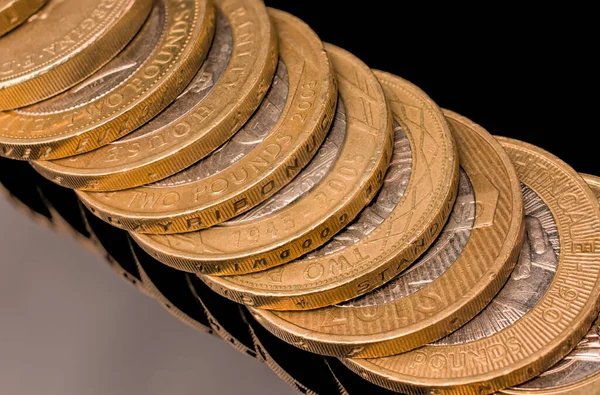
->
[77,8,337,235]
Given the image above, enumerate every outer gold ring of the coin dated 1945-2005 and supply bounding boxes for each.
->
[139,45,393,276]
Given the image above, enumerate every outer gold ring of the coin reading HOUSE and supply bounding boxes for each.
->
[33,0,278,192]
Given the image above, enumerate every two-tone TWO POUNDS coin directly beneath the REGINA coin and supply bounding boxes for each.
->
[0,0,215,161]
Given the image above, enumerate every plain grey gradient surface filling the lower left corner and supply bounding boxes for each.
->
[0,200,296,395]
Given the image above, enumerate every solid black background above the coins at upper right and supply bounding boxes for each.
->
[265,0,600,175]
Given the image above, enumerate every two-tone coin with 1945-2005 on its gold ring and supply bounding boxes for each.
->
[134,45,394,275]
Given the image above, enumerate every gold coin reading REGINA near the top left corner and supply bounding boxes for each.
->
[0,0,152,110]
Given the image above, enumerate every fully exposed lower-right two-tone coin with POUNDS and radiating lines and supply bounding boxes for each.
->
[342,138,600,395]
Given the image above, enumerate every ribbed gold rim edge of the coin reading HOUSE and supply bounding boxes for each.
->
[32,0,277,192]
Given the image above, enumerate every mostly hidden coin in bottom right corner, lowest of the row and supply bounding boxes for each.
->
[499,174,600,395]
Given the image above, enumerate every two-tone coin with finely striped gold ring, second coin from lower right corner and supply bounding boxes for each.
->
[252,111,523,358]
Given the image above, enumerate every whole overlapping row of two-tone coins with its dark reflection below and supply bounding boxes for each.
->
[0,0,600,394]
